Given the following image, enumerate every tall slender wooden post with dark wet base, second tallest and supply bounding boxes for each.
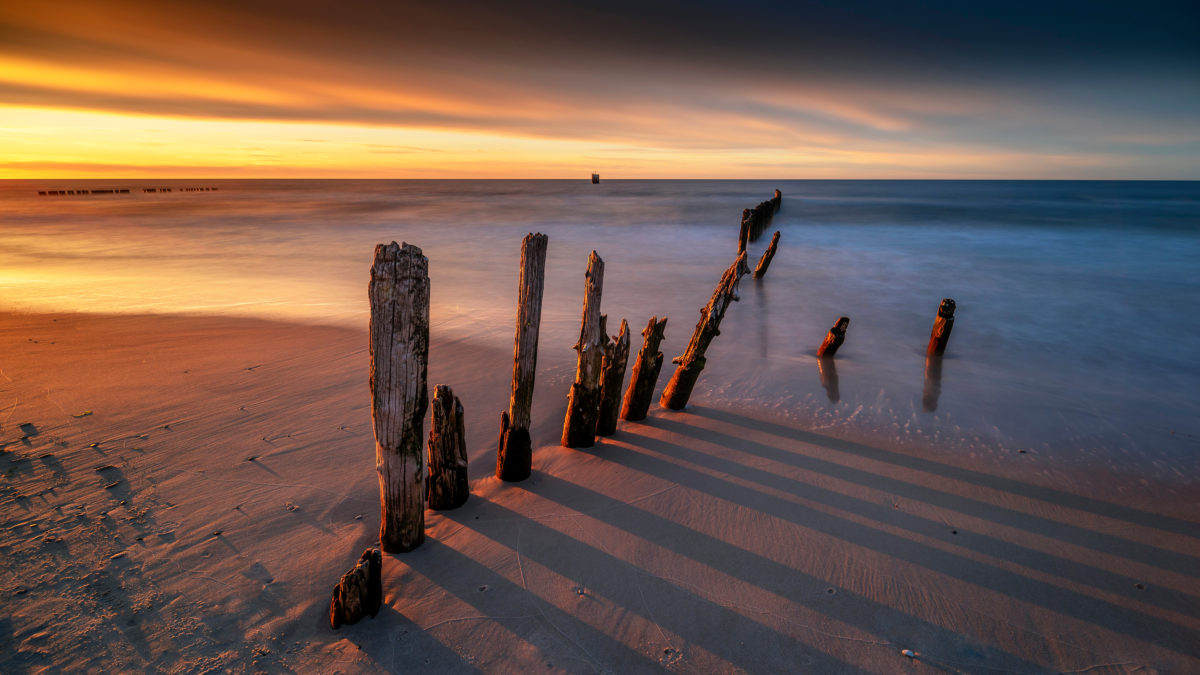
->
[496,233,547,480]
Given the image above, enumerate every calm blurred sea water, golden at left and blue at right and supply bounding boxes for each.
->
[0,180,1200,480]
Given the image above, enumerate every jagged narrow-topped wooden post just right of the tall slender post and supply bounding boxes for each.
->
[562,251,607,448]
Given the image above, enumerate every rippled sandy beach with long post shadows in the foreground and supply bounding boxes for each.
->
[0,313,1200,673]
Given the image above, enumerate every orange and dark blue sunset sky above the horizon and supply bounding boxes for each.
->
[0,0,1200,180]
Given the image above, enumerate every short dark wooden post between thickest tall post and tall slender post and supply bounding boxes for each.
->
[425,384,470,510]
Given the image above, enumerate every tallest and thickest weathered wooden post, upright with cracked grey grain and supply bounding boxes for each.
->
[368,241,430,552]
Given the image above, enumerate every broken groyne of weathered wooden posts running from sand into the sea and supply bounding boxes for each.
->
[330,190,954,628]
